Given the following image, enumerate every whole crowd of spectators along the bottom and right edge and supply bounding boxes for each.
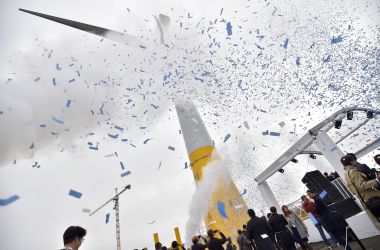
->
[59,153,380,250]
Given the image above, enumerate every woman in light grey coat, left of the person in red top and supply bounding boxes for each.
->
[282,205,313,250]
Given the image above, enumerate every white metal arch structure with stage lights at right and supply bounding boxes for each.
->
[255,107,380,211]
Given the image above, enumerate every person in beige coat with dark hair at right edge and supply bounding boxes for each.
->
[341,154,380,230]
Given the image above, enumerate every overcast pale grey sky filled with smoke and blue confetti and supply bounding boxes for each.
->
[0,0,380,250]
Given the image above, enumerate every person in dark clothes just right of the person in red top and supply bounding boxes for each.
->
[306,189,352,250]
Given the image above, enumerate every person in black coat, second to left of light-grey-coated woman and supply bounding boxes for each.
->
[247,209,276,250]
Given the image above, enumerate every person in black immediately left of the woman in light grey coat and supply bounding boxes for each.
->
[269,207,296,250]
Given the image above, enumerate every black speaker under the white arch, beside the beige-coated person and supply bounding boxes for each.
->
[302,170,344,205]
